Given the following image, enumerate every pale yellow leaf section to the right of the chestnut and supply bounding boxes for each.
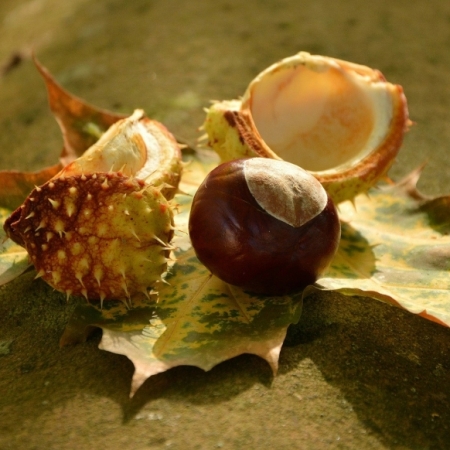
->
[317,169,450,326]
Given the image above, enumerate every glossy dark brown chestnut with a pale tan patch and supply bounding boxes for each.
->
[189,157,341,295]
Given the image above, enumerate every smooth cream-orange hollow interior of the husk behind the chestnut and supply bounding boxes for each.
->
[243,54,393,172]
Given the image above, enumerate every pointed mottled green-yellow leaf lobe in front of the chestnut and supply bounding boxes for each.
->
[110,250,302,394]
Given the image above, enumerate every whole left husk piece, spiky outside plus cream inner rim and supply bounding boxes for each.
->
[4,110,182,302]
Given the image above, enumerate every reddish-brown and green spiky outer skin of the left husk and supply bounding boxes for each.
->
[5,172,173,301]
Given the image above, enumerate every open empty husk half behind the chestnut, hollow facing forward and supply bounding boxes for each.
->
[204,52,410,203]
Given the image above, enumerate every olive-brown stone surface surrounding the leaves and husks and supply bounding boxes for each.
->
[0,0,450,450]
